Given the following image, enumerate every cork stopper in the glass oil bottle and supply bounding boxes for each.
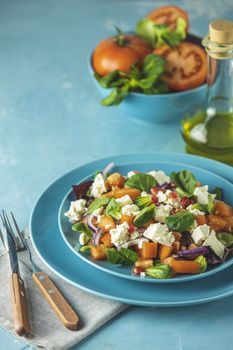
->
[209,19,233,45]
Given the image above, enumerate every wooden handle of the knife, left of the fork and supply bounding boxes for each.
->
[11,273,32,336]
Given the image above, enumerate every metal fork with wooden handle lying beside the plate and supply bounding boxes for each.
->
[1,212,79,330]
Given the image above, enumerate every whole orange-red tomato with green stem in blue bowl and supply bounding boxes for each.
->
[92,33,151,76]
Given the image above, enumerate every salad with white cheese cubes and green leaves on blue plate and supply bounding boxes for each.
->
[64,164,233,279]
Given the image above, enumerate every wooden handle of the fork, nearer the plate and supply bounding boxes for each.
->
[32,271,79,331]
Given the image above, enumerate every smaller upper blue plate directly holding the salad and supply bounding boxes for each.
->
[58,162,233,283]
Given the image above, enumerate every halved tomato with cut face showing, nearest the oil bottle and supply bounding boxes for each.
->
[153,41,207,91]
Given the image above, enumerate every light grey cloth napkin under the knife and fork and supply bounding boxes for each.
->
[0,230,127,350]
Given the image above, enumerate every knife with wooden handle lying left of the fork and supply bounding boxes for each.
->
[5,226,32,336]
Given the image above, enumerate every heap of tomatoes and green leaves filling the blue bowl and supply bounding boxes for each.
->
[92,6,207,106]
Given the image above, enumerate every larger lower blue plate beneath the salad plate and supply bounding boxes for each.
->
[30,153,233,307]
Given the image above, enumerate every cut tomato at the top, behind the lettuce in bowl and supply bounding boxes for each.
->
[147,6,189,32]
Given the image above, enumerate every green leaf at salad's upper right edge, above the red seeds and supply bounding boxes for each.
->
[171,170,197,197]
